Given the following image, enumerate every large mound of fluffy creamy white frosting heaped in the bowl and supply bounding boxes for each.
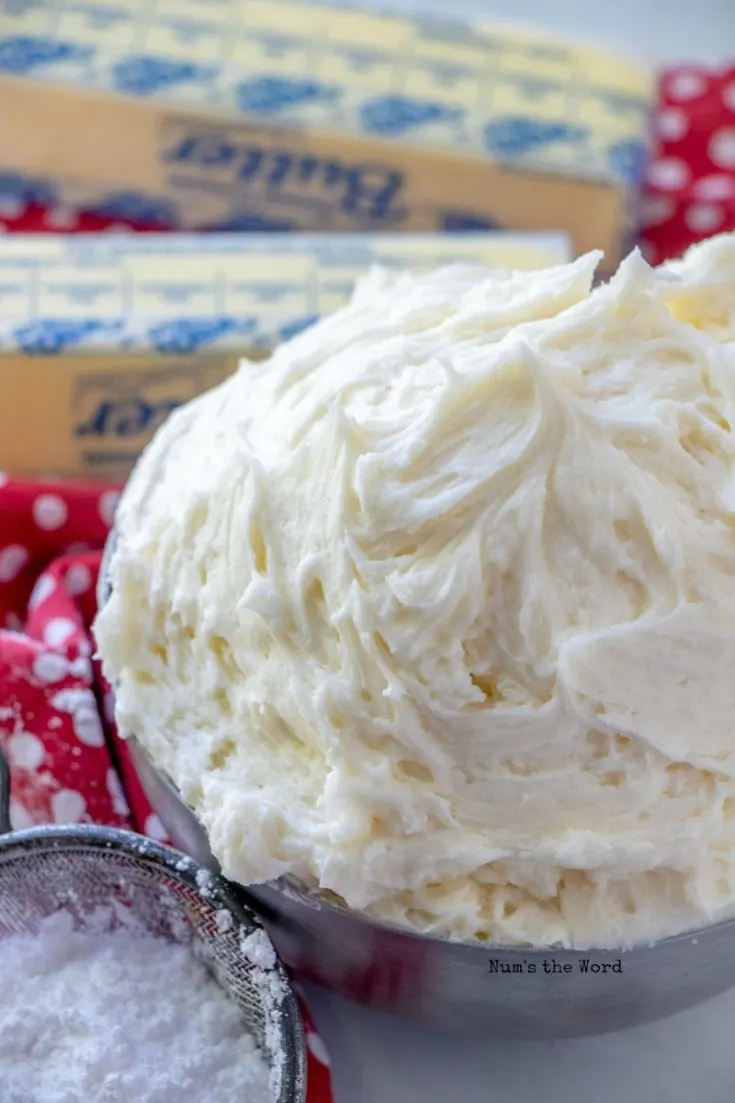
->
[96,238,735,947]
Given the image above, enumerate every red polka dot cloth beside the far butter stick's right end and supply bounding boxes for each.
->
[641,65,735,264]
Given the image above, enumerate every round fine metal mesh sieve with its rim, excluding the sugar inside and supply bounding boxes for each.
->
[0,752,306,1103]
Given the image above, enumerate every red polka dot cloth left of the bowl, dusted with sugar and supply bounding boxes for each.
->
[0,475,332,1103]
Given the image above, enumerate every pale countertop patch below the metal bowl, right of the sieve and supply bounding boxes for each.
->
[308,987,735,1103]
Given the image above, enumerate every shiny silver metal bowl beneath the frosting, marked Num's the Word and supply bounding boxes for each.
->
[130,740,735,1039]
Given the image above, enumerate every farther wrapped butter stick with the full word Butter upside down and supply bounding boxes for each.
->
[0,0,653,259]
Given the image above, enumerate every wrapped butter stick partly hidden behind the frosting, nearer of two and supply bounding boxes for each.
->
[0,234,569,479]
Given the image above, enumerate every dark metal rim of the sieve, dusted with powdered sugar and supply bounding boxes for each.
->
[0,811,307,1103]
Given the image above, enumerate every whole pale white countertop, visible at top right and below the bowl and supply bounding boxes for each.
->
[295,0,735,1103]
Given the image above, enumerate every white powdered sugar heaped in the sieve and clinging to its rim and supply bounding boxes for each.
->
[0,912,273,1103]
